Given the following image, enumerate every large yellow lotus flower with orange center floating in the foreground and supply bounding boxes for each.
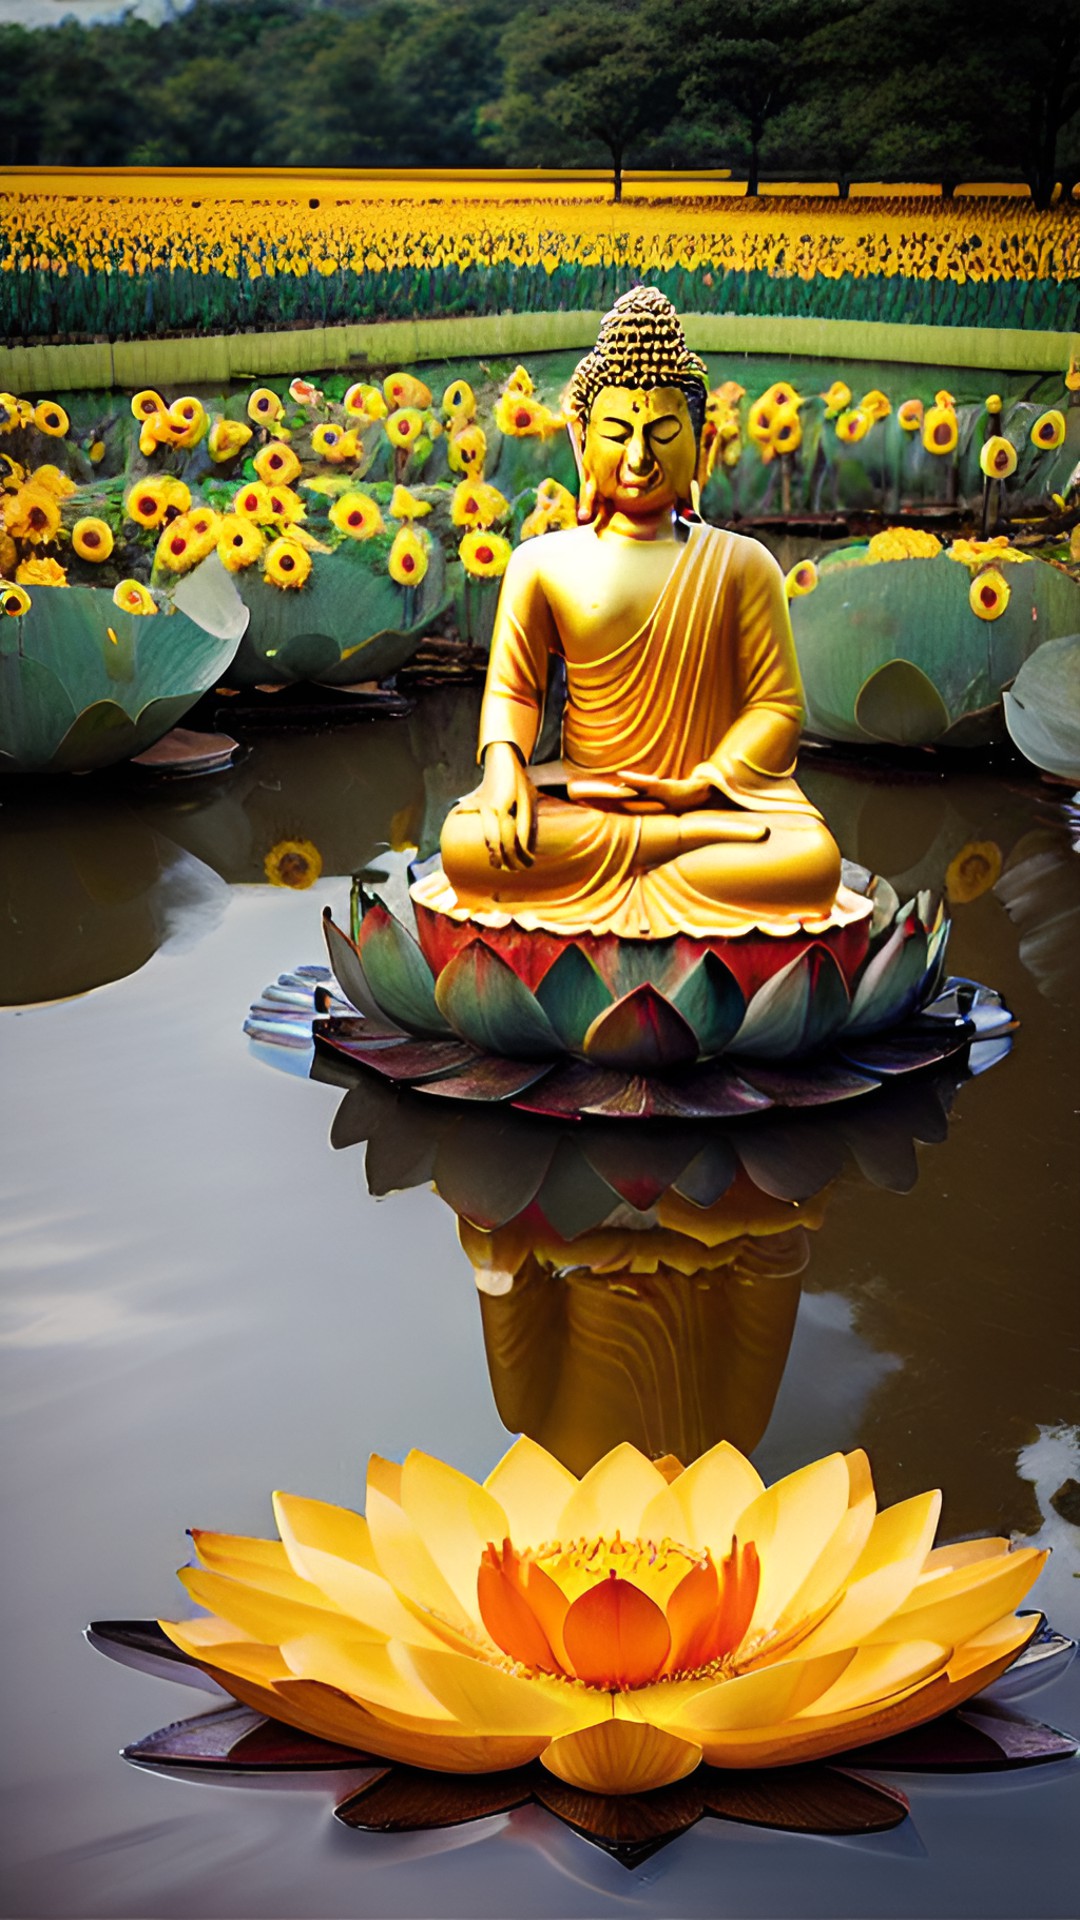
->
[161,1440,1045,1793]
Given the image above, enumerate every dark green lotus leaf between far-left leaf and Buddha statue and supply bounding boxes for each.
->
[229,540,446,685]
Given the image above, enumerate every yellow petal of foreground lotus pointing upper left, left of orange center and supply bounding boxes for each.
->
[273,1494,453,1645]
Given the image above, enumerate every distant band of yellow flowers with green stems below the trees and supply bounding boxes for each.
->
[0,186,1080,340]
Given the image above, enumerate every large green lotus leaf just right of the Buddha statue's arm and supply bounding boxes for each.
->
[792,549,1080,745]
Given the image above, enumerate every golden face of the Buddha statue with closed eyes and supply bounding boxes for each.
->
[582,386,698,520]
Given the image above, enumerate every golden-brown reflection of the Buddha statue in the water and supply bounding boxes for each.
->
[459,1171,824,1473]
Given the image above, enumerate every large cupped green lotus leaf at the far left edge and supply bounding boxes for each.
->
[0,588,236,772]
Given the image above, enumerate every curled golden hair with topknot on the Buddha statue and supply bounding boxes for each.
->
[565,286,709,434]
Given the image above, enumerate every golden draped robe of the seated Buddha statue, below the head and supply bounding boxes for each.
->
[413,524,869,939]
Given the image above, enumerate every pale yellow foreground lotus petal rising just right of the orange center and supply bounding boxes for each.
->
[736,1453,851,1634]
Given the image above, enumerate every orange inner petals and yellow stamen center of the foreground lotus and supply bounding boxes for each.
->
[477,1532,759,1692]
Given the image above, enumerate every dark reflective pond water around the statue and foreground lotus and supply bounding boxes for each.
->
[0,691,1080,1920]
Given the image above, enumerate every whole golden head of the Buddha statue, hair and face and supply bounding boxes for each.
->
[567,286,709,520]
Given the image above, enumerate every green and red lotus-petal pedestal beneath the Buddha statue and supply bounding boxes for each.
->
[309,866,970,1119]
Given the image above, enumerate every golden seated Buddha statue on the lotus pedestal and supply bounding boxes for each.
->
[415,288,869,937]
